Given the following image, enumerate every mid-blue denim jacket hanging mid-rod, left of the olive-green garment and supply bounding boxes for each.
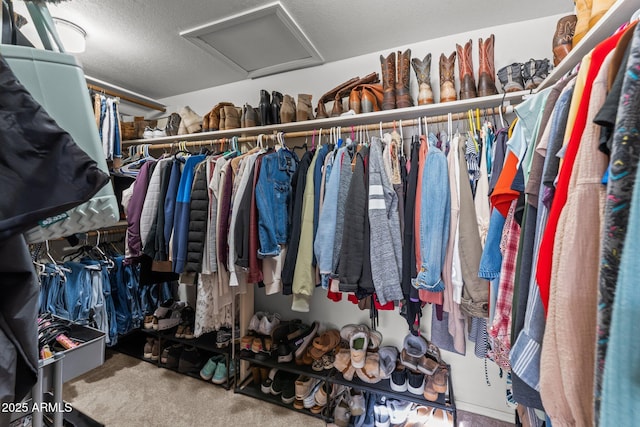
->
[256,149,298,258]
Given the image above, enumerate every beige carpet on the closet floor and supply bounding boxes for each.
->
[63,351,325,427]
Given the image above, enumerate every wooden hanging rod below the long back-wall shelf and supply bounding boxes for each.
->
[122,105,514,150]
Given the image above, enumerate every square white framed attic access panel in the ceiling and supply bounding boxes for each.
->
[180,2,323,78]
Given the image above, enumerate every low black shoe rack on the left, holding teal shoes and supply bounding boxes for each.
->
[114,328,235,390]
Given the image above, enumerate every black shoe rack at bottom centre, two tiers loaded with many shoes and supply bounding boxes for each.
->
[235,350,457,426]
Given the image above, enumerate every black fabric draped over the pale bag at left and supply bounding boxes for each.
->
[0,52,109,240]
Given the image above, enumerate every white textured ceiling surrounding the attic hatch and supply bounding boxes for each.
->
[16,0,573,99]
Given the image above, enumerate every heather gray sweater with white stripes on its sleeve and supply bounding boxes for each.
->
[368,137,403,304]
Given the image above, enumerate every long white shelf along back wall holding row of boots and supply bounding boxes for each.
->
[122,90,530,145]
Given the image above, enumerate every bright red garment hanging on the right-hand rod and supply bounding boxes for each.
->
[536,31,624,312]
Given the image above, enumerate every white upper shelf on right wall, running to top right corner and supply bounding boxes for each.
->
[536,0,640,91]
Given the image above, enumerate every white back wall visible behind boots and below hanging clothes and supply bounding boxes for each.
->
[162,15,561,421]
